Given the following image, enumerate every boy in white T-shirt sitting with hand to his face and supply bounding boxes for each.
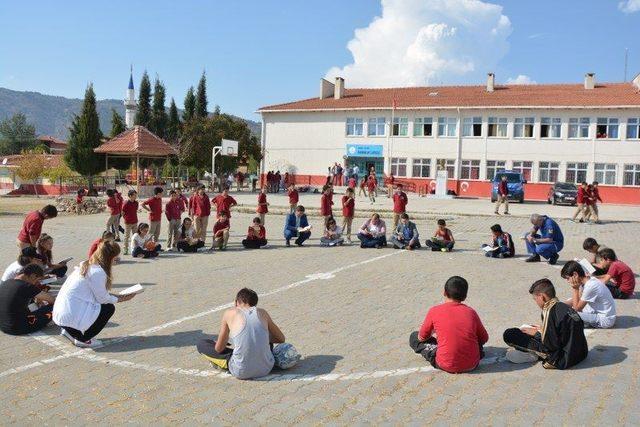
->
[560,261,616,328]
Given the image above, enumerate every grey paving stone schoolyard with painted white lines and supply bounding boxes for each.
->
[0,196,640,425]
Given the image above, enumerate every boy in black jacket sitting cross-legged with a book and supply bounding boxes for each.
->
[503,279,589,369]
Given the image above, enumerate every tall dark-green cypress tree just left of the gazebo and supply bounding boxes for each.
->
[64,85,104,190]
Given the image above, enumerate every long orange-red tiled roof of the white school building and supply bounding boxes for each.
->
[258,83,640,112]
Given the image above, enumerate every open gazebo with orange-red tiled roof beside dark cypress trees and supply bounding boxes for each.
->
[93,125,178,193]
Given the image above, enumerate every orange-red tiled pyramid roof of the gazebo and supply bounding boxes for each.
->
[93,126,178,156]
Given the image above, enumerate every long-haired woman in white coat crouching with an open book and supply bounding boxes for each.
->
[53,241,134,348]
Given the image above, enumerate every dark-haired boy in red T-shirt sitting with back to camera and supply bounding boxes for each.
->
[409,276,489,374]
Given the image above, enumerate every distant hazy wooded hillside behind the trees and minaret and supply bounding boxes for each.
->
[0,88,261,140]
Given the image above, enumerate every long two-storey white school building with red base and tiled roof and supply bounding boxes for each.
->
[258,73,640,204]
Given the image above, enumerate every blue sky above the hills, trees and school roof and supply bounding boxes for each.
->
[0,0,640,120]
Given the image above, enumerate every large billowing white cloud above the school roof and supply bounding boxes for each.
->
[326,0,511,87]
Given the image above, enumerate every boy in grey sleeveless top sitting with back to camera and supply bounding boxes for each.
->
[197,288,284,380]
